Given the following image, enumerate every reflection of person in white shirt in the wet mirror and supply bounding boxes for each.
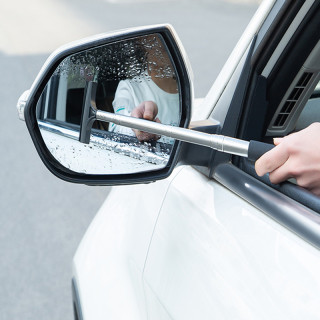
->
[109,36,180,143]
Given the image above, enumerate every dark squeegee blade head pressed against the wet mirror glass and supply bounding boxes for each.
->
[79,81,98,144]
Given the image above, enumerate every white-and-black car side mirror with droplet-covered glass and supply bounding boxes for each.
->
[18,25,192,185]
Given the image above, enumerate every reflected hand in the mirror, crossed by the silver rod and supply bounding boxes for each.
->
[131,101,160,142]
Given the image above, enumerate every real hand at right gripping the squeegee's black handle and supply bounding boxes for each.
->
[255,122,320,196]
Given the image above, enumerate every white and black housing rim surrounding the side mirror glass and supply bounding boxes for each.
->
[22,25,193,185]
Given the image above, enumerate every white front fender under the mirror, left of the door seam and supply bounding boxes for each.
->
[73,168,180,320]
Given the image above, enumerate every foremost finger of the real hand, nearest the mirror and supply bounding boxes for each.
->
[255,144,289,176]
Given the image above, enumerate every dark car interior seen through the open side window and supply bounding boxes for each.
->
[234,3,320,212]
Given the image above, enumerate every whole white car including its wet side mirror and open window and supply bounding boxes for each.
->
[18,0,320,320]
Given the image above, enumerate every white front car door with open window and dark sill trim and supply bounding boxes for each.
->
[144,1,320,319]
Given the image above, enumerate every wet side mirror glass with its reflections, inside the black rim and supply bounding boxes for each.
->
[36,34,181,174]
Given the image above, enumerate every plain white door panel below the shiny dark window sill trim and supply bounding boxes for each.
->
[144,167,320,319]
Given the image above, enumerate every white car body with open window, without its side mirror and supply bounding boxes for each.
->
[18,0,320,320]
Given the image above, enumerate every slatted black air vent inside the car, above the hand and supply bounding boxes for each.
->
[273,72,312,128]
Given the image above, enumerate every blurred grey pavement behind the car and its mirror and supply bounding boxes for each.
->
[0,0,261,320]
